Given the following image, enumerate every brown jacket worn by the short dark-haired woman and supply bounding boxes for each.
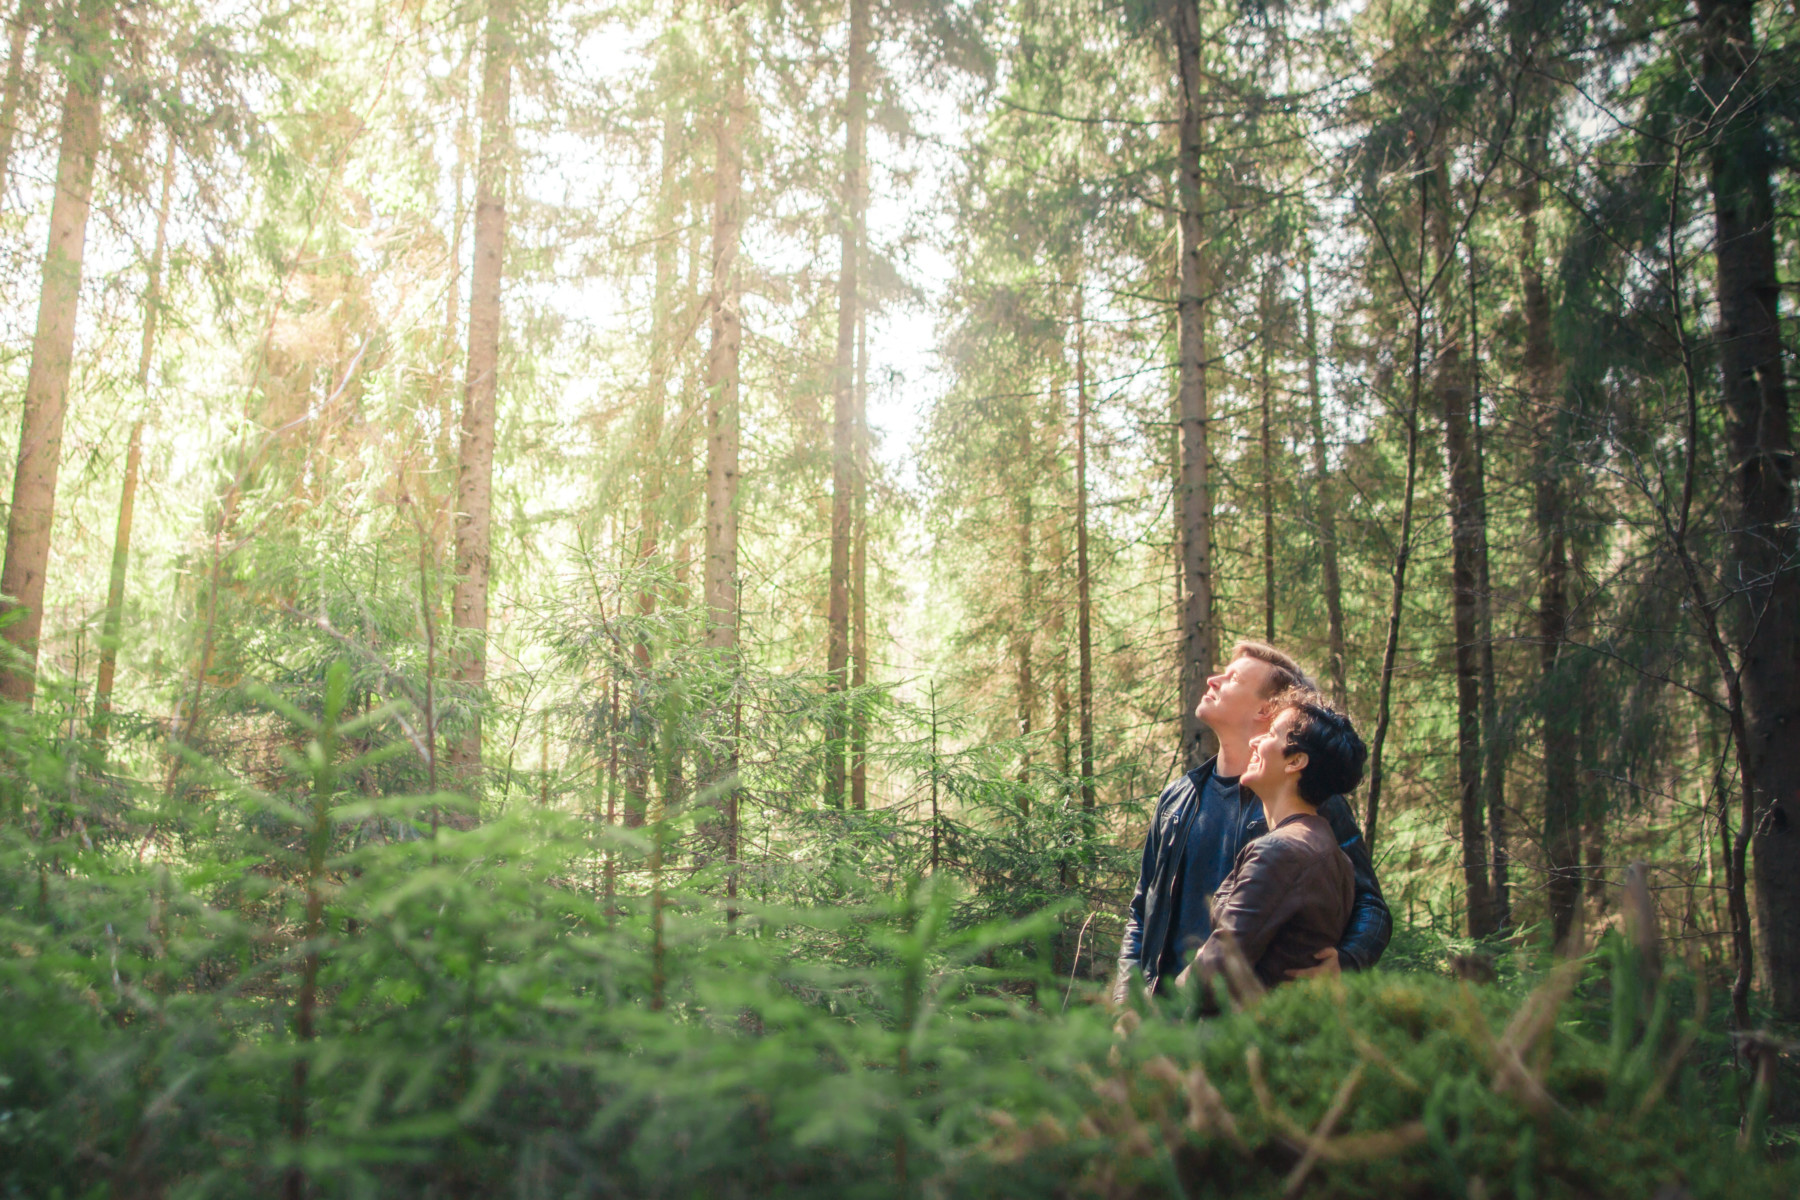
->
[1193,813,1355,997]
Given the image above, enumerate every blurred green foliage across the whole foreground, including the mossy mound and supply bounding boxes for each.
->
[0,667,1800,1198]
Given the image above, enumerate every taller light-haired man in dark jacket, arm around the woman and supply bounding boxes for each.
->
[1112,642,1393,1002]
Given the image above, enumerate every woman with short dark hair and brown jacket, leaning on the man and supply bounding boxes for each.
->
[1175,693,1368,1007]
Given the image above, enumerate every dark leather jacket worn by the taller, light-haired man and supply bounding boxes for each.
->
[1112,759,1393,1000]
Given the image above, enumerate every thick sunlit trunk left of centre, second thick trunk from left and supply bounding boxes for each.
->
[450,0,513,788]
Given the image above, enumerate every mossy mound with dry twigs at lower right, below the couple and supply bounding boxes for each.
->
[952,950,1800,1200]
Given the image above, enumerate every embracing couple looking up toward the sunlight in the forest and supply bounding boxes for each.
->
[1112,642,1393,1006]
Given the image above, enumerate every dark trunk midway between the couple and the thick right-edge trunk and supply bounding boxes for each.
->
[1519,175,1580,946]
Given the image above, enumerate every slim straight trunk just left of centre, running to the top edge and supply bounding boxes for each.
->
[824,0,869,808]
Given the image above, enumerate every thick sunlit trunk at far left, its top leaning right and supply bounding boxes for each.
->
[0,0,112,705]
